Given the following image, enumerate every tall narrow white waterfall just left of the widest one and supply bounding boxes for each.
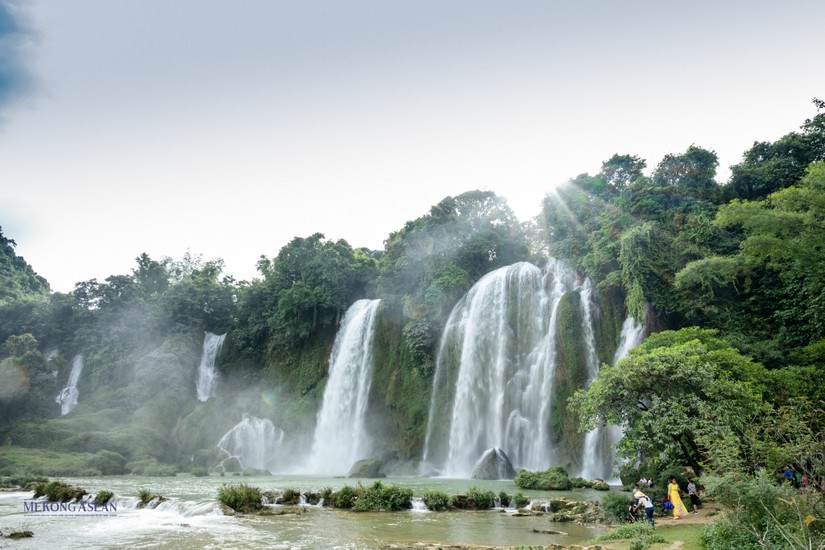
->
[308,300,380,475]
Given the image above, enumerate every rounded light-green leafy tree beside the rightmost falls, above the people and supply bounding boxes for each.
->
[570,327,764,475]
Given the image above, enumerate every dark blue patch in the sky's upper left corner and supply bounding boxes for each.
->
[0,0,35,123]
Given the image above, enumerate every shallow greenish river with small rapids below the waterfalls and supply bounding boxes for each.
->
[0,474,605,549]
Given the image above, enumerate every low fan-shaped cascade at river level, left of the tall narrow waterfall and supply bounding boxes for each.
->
[217,414,284,472]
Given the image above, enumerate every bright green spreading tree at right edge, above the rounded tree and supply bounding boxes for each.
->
[676,161,825,354]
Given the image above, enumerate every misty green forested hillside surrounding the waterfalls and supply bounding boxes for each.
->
[0,101,825,524]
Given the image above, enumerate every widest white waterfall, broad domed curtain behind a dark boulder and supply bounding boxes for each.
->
[423,259,576,478]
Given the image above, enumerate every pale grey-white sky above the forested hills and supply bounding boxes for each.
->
[0,0,825,292]
